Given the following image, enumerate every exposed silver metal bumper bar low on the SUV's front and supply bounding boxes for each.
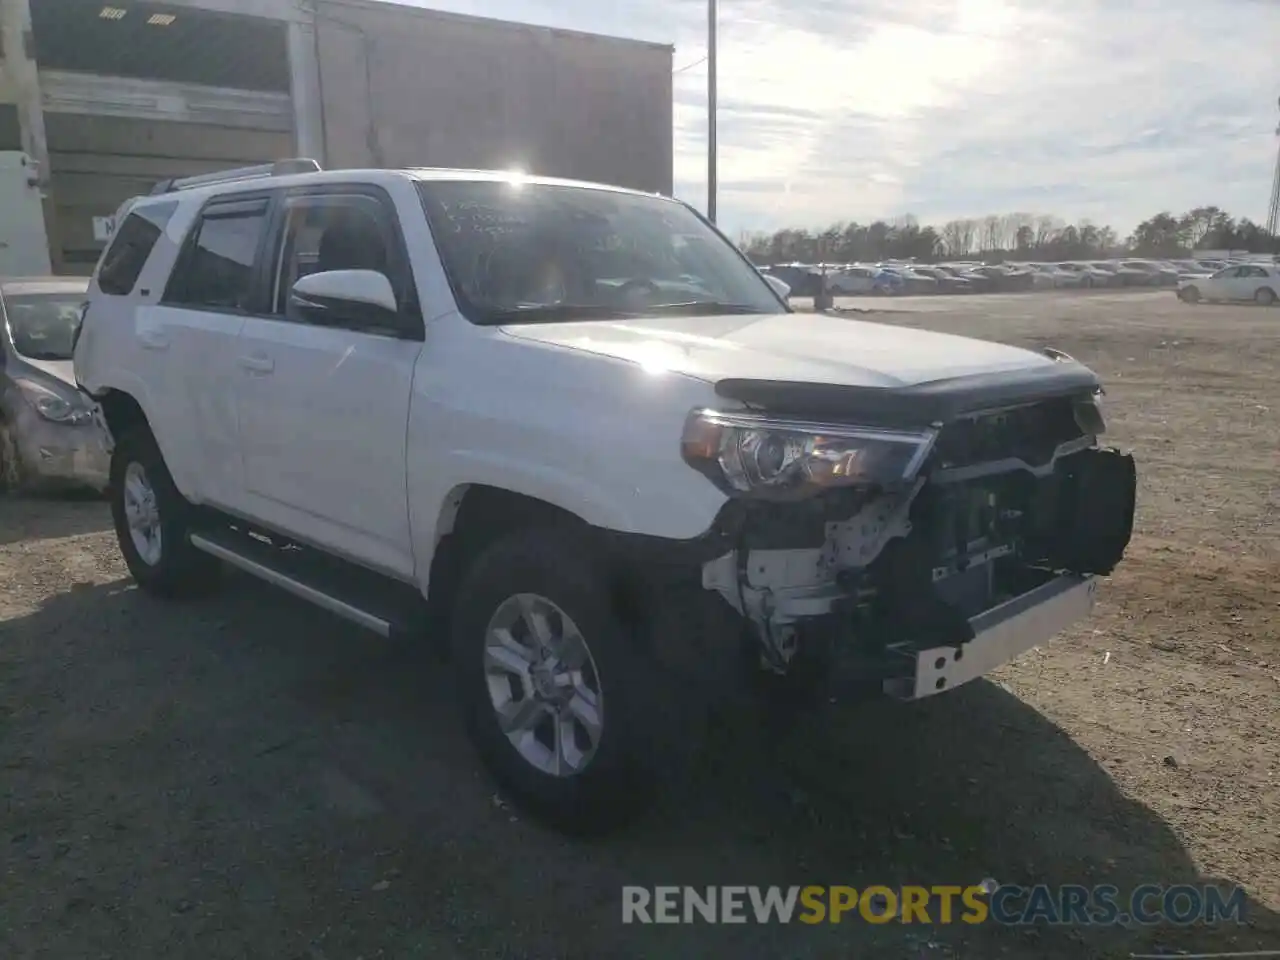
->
[884,575,1097,700]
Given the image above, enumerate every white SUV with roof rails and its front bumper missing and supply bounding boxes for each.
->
[76,161,1135,828]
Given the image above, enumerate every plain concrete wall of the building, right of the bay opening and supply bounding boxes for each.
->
[315,0,672,193]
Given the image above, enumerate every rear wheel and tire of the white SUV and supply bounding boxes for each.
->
[108,426,221,598]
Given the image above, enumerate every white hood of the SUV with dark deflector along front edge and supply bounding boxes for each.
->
[502,314,1097,417]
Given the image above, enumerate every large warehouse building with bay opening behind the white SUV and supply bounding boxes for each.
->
[0,0,672,273]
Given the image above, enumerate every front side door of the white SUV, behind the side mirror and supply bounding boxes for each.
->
[234,184,424,577]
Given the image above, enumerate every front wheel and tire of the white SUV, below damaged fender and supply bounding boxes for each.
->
[453,527,666,833]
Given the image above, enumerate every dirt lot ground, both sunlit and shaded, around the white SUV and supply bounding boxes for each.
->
[0,293,1280,960]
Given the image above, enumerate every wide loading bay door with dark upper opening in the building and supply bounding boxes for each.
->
[32,0,294,273]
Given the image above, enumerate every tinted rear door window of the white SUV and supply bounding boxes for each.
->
[165,200,268,310]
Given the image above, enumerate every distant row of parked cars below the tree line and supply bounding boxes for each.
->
[763,260,1249,297]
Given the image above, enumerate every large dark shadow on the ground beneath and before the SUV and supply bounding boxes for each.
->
[0,576,1280,960]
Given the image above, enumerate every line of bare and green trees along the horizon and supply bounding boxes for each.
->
[739,206,1280,264]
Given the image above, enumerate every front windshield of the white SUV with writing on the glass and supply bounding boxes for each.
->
[419,180,787,324]
